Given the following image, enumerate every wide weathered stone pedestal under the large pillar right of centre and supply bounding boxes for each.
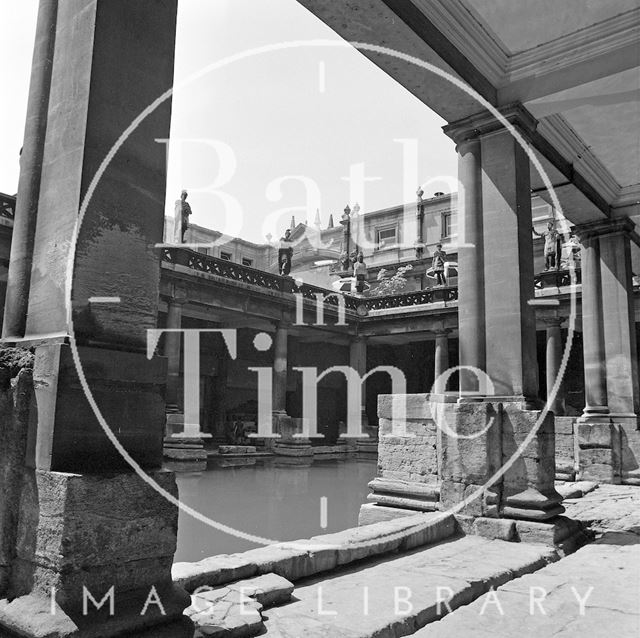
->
[363,394,564,530]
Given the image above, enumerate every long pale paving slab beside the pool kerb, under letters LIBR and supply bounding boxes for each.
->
[263,536,558,638]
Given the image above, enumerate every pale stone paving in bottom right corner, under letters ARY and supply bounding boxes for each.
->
[413,528,640,638]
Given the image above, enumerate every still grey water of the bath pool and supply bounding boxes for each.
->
[175,458,376,561]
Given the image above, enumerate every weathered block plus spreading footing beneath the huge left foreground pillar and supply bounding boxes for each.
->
[0,471,189,638]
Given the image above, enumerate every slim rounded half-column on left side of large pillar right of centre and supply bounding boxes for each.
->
[456,136,486,392]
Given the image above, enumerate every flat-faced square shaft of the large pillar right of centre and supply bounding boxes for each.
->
[481,127,538,403]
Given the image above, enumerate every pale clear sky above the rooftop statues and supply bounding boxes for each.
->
[0,0,457,242]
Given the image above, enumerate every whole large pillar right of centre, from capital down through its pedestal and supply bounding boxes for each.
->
[436,104,563,521]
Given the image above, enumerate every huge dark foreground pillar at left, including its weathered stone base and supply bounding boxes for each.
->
[0,0,193,638]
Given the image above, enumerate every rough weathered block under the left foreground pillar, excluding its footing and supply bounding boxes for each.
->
[11,471,185,606]
